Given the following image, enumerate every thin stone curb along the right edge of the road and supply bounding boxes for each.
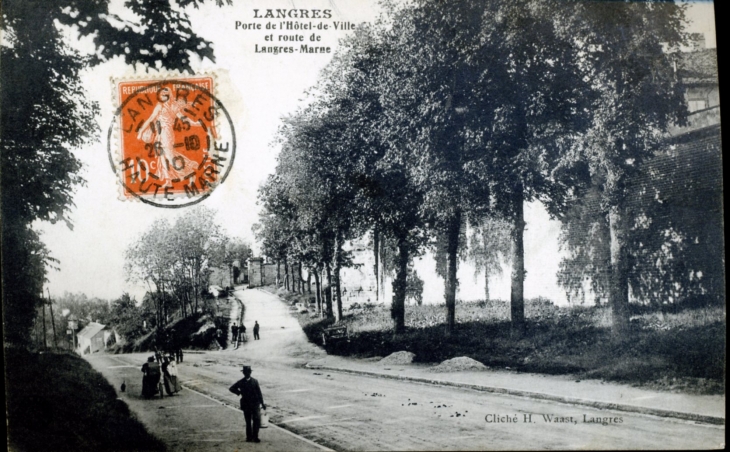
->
[305,364,725,425]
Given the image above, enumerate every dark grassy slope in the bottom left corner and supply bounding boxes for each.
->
[5,349,164,451]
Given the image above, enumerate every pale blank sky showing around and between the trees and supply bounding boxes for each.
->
[37,0,715,304]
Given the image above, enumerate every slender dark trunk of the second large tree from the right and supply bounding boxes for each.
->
[510,183,525,334]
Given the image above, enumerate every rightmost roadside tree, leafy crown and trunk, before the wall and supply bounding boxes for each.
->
[574,1,686,340]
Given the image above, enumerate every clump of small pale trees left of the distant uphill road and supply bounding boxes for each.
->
[125,206,252,332]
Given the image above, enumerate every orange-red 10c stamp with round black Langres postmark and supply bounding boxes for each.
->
[107,76,236,208]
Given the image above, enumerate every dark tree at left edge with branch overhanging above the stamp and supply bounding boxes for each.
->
[0,0,230,344]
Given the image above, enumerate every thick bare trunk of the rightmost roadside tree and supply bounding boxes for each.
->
[608,206,630,341]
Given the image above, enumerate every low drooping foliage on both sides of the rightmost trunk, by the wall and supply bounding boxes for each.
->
[558,129,724,308]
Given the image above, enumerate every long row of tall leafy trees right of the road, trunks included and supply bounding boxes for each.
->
[258,0,686,337]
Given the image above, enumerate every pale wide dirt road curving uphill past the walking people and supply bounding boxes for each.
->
[85,290,724,451]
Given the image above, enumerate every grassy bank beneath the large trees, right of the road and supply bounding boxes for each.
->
[272,295,726,394]
